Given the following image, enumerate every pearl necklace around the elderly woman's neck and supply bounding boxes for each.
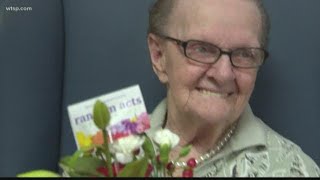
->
[171,123,237,168]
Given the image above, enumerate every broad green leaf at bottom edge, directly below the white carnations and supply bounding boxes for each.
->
[118,157,148,177]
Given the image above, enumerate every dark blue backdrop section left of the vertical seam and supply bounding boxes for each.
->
[0,0,64,176]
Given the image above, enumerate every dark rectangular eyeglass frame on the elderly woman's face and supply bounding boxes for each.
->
[156,34,269,69]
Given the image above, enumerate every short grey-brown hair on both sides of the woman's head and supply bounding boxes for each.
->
[148,0,270,48]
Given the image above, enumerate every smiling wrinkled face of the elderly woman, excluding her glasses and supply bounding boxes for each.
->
[149,0,260,124]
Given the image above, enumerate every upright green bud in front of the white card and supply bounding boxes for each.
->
[93,100,110,130]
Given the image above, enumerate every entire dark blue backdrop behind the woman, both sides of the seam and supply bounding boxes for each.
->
[0,0,320,176]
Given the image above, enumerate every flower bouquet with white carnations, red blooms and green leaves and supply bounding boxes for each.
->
[18,100,196,177]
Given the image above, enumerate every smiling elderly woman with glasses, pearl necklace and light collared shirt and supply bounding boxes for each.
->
[148,0,320,177]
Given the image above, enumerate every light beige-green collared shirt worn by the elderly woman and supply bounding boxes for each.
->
[147,99,320,177]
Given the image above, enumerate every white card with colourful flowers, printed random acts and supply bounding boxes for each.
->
[68,85,150,149]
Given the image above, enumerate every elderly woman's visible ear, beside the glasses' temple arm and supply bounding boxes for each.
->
[148,33,168,84]
